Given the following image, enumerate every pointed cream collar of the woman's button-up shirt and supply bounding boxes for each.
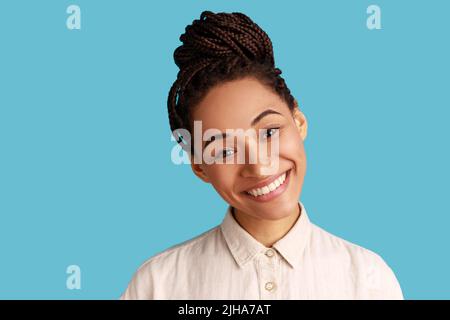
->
[220,201,311,268]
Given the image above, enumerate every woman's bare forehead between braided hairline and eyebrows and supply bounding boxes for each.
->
[192,78,288,130]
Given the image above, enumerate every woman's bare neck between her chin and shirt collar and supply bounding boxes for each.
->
[232,206,301,248]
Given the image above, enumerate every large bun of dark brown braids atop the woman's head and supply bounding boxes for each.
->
[174,11,274,70]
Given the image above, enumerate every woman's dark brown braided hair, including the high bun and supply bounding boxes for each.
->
[167,11,296,154]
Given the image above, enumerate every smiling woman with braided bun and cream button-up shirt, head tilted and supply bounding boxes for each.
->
[121,11,403,299]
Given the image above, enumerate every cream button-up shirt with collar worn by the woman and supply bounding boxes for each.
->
[120,202,403,300]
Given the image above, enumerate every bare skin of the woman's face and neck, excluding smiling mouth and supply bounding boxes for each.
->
[191,77,307,247]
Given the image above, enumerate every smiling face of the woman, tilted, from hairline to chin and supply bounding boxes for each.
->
[191,77,307,220]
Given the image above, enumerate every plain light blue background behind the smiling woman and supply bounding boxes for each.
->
[0,0,450,299]
